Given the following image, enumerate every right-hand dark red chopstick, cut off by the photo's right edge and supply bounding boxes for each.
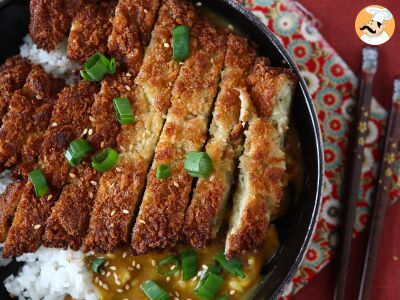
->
[358,78,400,300]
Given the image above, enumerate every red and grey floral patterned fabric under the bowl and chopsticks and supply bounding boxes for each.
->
[238,0,400,299]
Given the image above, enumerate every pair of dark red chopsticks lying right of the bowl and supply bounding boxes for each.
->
[334,47,400,300]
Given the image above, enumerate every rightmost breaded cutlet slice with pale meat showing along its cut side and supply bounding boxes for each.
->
[225,58,296,258]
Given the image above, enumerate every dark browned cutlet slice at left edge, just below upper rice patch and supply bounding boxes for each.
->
[0,65,64,172]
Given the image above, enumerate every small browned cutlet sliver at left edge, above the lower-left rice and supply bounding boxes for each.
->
[0,181,25,243]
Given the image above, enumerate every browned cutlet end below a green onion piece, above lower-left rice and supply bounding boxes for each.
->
[3,182,57,257]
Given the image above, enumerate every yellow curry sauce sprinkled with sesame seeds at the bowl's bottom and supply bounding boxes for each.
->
[86,225,279,300]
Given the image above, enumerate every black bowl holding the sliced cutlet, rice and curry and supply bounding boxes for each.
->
[0,0,323,299]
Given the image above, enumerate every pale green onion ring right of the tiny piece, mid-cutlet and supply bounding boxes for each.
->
[184,151,212,177]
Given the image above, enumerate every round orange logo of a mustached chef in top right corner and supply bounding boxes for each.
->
[355,5,395,45]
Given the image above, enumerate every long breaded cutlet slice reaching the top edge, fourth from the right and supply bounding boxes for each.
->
[84,0,194,252]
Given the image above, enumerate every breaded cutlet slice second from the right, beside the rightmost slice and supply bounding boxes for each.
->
[184,34,256,248]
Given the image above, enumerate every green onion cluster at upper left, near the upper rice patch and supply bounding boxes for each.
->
[80,52,116,81]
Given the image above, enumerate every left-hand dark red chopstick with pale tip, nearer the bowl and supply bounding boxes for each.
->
[334,47,378,300]
